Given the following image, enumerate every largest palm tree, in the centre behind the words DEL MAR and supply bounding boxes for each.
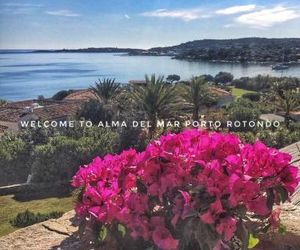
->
[131,74,177,137]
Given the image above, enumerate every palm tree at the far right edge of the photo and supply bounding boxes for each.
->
[273,82,300,128]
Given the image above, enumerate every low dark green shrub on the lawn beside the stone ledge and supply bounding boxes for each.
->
[10,210,64,227]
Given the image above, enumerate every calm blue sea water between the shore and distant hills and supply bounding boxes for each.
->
[0,53,300,100]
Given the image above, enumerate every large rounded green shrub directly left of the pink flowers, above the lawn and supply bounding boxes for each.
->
[32,128,118,182]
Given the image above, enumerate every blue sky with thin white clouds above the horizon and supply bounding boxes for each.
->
[0,0,300,49]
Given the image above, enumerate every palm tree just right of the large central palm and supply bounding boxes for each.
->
[181,77,208,121]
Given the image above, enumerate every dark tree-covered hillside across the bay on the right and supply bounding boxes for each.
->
[143,37,300,63]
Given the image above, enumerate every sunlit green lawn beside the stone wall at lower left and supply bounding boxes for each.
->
[0,195,74,237]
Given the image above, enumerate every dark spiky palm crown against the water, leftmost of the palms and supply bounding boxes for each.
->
[90,78,121,104]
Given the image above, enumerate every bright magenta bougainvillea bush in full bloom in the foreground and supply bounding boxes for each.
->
[72,130,299,250]
